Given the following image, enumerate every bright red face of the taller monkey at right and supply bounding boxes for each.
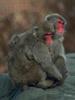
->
[56,18,64,35]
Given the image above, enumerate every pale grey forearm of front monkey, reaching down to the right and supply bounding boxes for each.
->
[32,42,62,80]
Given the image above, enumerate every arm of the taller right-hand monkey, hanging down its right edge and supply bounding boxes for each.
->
[55,42,68,79]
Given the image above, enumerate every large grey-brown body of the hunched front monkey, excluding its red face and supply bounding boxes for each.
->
[8,25,62,89]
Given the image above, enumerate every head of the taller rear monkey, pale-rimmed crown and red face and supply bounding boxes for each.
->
[44,13,67,37]
